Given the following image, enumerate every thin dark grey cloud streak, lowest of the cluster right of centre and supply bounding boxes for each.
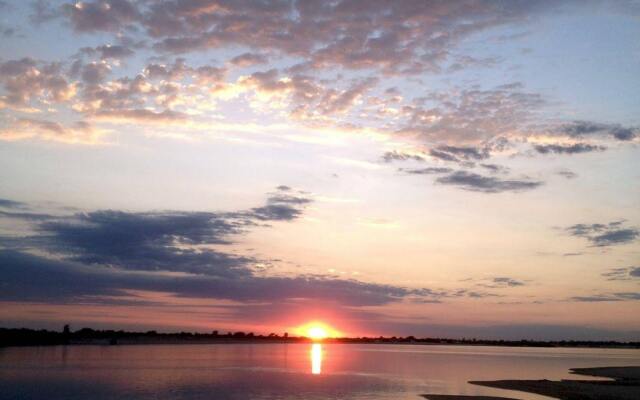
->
[436,171,542,193]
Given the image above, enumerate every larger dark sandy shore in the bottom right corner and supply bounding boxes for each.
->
[464,366,640,400]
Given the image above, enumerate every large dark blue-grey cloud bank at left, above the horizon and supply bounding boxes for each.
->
[0,189,500,306]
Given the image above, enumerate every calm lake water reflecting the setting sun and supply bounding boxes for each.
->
[0,344,640,400]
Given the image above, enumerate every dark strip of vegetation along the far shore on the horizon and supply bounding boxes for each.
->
[0,325,640,348]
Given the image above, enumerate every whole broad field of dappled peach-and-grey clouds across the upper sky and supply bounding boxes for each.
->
[3,0,636,159]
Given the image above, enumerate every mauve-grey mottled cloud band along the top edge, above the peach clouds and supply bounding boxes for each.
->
[131,1,564,73]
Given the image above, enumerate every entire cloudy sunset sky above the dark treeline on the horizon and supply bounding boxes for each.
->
[0,0,640,340]
